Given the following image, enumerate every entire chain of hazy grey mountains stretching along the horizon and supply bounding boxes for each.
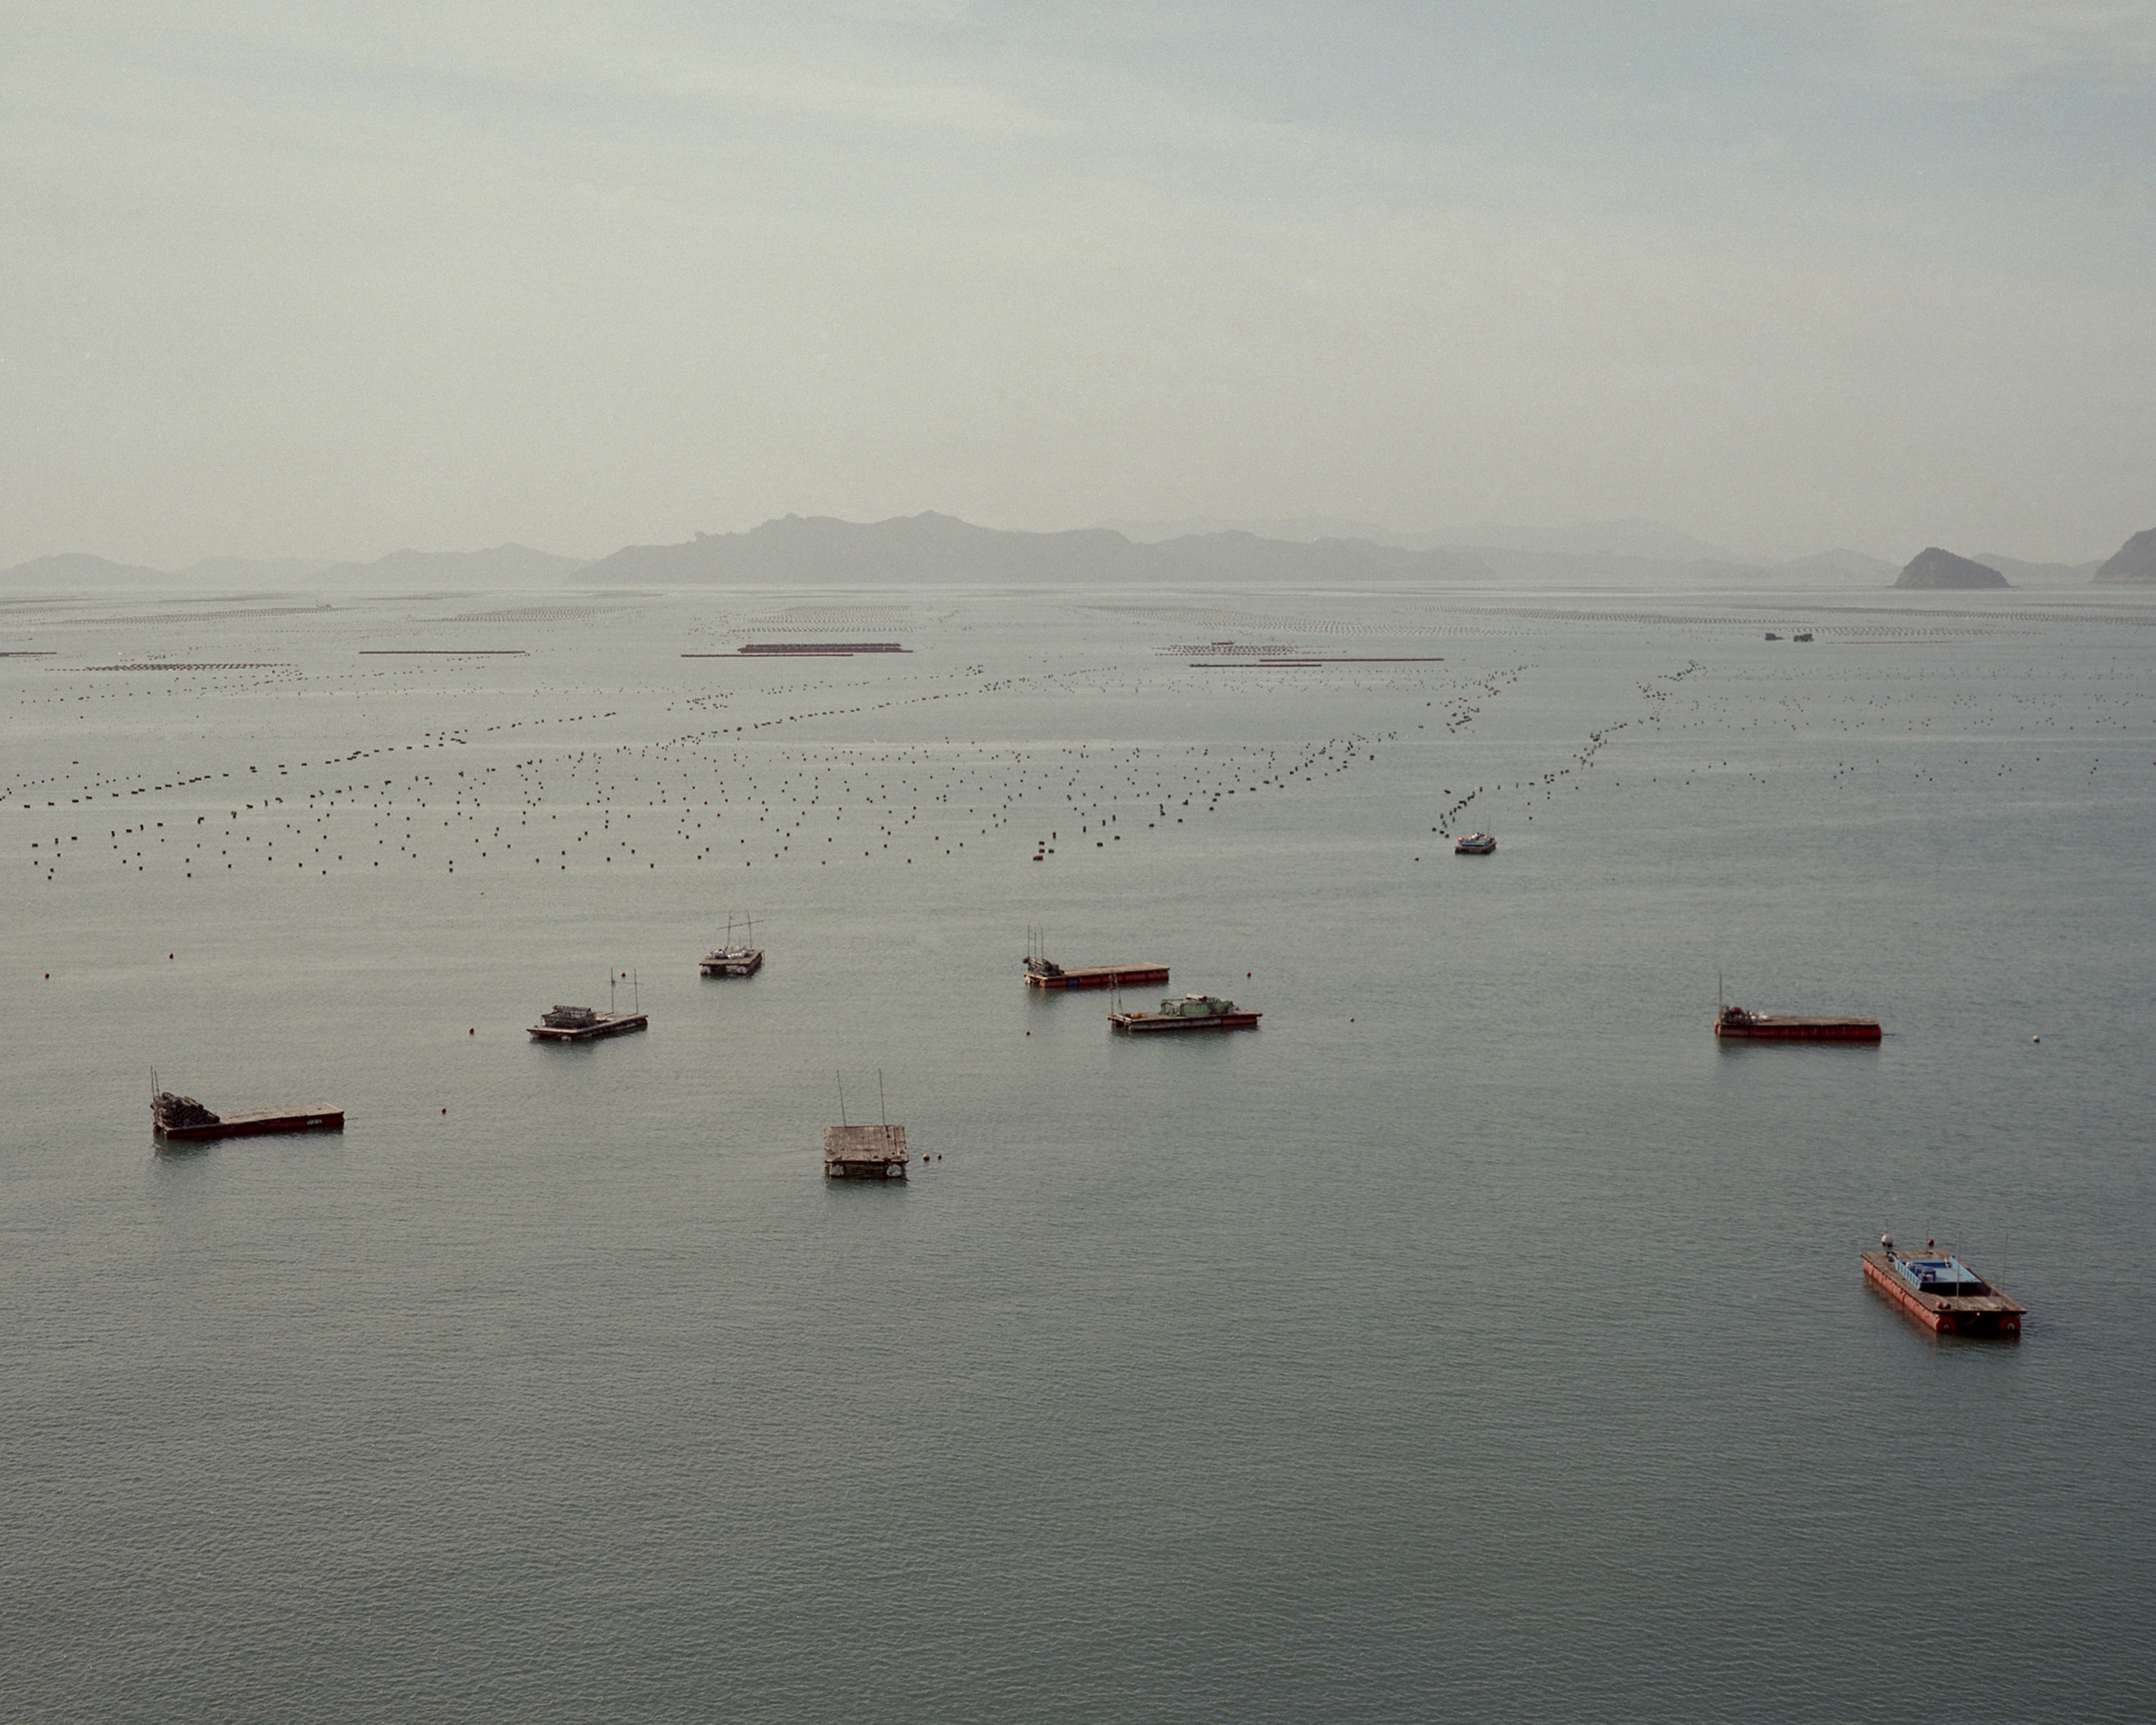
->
[12,511,2156,591]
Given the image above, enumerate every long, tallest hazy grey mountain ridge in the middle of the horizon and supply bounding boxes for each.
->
[578,511,1488,586]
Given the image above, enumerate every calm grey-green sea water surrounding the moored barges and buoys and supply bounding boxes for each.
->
[0,591,2156,1721]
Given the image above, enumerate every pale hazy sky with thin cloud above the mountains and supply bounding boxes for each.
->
[0,0,2156,565]
